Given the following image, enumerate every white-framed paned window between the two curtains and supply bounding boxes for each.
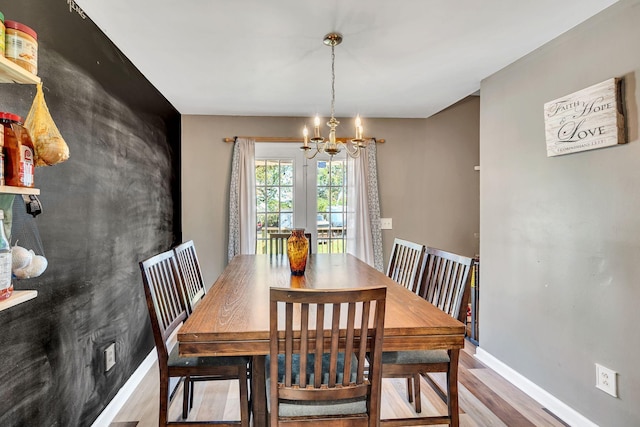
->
[256,143,347,254]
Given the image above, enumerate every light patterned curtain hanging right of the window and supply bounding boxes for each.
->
[347,140,384,271]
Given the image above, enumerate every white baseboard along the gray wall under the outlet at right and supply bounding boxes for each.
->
[476,347,598,427]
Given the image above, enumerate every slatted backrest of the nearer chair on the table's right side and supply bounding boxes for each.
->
[418,248,473,322]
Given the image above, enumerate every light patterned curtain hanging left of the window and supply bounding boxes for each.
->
[227,138,256,261]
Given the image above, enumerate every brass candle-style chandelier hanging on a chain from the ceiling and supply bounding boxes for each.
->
[300,33,367,159]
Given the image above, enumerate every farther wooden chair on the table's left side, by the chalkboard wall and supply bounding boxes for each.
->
[173,240,206,315]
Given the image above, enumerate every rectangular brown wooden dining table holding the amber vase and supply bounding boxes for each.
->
[178,254,465,426]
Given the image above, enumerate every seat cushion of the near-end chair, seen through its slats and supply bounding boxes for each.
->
[266,353,367,417]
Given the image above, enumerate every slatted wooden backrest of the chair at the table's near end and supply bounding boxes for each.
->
[269,287,386,420]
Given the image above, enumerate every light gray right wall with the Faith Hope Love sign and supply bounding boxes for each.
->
[480,0,640,427]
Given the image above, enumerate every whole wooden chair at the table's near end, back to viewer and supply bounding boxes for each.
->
[266,287,387,427]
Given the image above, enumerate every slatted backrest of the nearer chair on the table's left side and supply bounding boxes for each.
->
[140,251,187,361]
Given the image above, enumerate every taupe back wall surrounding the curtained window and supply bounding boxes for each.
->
[182,97,480,283]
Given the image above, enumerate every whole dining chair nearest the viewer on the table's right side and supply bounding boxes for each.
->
[382,248,473,425]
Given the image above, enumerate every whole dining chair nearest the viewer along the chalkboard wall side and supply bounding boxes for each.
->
[139,250,250,427]
